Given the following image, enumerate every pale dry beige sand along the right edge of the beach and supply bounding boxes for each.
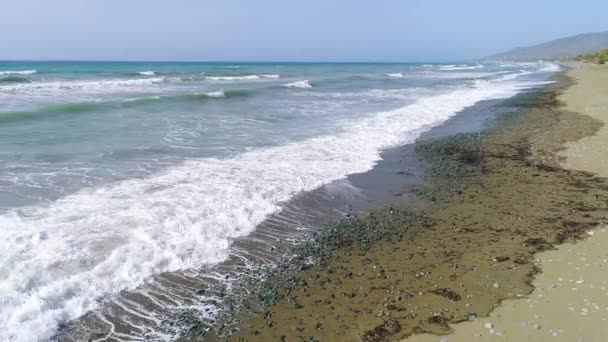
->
[407,64,608,342]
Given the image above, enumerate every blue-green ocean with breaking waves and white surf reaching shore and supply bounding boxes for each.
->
[0,62,559,341]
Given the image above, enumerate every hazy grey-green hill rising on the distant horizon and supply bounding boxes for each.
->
[484,31,608,61]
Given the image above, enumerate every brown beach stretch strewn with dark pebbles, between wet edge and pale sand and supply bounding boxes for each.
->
[194,65,608,341]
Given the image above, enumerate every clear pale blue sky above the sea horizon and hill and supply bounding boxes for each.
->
[0,0,608,61]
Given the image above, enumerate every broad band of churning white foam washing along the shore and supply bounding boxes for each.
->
[0,73,536,341]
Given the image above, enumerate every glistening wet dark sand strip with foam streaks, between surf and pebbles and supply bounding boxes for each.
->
[55,66,546,341]
